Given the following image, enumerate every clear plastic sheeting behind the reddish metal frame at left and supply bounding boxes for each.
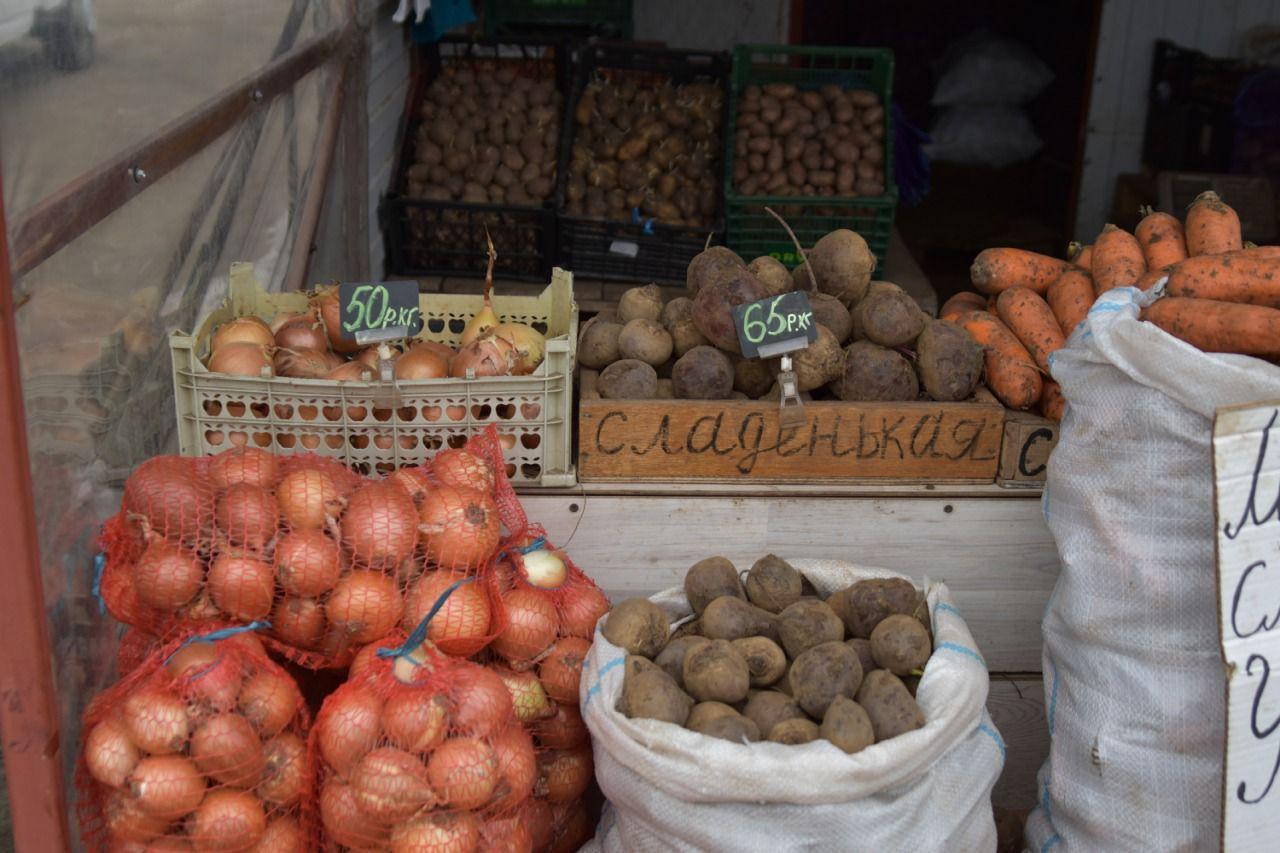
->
[0,0,347,836]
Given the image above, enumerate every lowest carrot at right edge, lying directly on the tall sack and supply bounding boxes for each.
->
[1142,296,1280,359]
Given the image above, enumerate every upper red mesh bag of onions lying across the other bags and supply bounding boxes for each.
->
[100,428,526,667]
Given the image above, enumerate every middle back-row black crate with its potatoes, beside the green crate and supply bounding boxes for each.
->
[556,45,731,283]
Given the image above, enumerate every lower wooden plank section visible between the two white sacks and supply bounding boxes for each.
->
[987,674,1048,809]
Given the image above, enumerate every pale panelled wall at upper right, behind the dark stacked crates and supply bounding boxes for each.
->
[1075,0,1280,242]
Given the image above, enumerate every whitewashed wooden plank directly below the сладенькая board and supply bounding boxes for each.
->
[521,493,1059,672]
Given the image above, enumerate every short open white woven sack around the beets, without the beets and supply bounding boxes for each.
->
[581,560,1005,853]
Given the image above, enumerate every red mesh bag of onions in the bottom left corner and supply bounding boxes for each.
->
[76,626,310,853]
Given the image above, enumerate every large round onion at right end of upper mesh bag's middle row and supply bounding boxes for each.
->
[417,485,502,569]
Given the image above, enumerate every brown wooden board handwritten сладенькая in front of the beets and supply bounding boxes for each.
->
[577,400,1005,483]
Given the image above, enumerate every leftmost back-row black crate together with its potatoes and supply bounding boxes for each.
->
[381,38,570,280]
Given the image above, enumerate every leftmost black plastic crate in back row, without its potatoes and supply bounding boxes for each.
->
[380,38,572,280]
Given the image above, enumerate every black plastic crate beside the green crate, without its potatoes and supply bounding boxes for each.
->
[556,45,732,283]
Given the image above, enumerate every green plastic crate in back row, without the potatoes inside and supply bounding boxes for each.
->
[724,45,897,265]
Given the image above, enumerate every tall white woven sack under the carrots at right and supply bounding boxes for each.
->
[1027,288,1280,853]
